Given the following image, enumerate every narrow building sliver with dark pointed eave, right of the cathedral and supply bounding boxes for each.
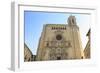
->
[84,29,91,59]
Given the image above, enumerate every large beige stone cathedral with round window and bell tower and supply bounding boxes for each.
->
[36,15,84,61]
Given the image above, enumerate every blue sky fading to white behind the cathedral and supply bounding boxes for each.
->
[24,11,90,54]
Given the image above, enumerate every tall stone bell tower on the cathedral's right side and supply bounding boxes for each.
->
[68,15,84,59]
